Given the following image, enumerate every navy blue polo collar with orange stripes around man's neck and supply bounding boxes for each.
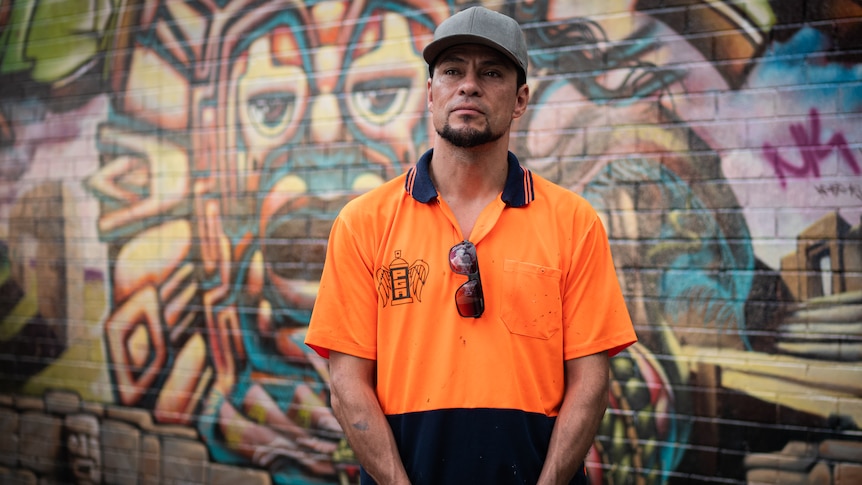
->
[404,149,536,207]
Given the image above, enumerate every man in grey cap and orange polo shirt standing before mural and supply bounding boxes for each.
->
[306,7,636,485]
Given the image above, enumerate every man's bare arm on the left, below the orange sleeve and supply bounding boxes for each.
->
[329,352,410,485]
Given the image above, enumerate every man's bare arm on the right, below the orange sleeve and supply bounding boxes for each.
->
[538,352,610,485]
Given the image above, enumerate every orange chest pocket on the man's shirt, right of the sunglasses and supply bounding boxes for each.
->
[500,260,563,339]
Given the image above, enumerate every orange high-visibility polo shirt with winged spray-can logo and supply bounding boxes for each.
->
[306,151,636,482]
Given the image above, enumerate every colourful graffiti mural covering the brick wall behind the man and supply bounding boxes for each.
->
[0,0,862,484]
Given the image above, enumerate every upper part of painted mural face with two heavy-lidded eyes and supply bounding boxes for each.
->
[230,2,436,193]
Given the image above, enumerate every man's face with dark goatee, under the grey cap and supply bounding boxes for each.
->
[428,44,529,148]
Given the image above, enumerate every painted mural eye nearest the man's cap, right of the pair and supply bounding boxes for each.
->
[350,77,413,125]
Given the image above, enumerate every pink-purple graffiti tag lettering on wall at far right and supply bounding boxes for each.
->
[763,108,860,187]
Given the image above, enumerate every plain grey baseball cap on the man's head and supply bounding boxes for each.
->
[422,7,527,77]
